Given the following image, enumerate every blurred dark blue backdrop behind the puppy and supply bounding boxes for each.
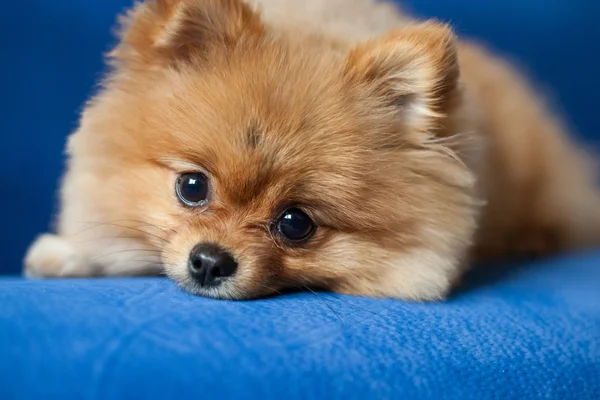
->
[0,0,600,273]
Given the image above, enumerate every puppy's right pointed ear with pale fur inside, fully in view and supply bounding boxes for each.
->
[345,21,459,132]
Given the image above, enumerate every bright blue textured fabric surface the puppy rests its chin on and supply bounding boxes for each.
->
[0,253,600,400]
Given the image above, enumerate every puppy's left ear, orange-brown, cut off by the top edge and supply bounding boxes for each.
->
[110,0,263,65]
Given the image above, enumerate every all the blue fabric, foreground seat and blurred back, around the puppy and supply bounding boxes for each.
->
[0,0,600,400]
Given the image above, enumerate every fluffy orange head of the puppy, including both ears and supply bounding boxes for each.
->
[70,0,474,299]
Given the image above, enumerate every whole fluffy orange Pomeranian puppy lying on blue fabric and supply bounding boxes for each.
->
[25,0,600,301]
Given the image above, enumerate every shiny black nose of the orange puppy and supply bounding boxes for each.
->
[188,243,237,286]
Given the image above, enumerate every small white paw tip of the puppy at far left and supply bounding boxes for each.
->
[24,234,84,278]
